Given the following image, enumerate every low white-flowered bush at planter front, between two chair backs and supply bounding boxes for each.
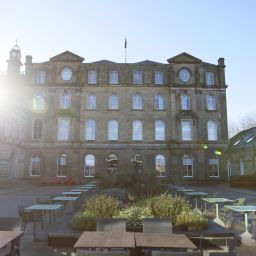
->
[116,206,152,232]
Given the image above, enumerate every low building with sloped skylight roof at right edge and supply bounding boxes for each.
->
[224,127,256,177]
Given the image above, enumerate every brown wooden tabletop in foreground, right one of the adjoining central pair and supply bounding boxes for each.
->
[135,233,197,249]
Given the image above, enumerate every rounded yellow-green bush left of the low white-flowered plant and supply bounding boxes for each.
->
[83,195,120,218]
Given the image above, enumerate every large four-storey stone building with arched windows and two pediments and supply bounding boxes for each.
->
[0,46,228,180]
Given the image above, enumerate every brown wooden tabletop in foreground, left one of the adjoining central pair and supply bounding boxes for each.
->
[74,231,135,249]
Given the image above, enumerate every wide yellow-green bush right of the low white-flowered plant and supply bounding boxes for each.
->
[150,194,191,223]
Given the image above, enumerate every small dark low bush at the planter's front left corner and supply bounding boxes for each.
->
[71,212,96,231]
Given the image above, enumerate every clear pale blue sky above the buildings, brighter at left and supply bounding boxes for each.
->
[0,0,256,124]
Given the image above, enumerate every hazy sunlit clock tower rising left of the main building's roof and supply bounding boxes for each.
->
[7,42,22,76]
